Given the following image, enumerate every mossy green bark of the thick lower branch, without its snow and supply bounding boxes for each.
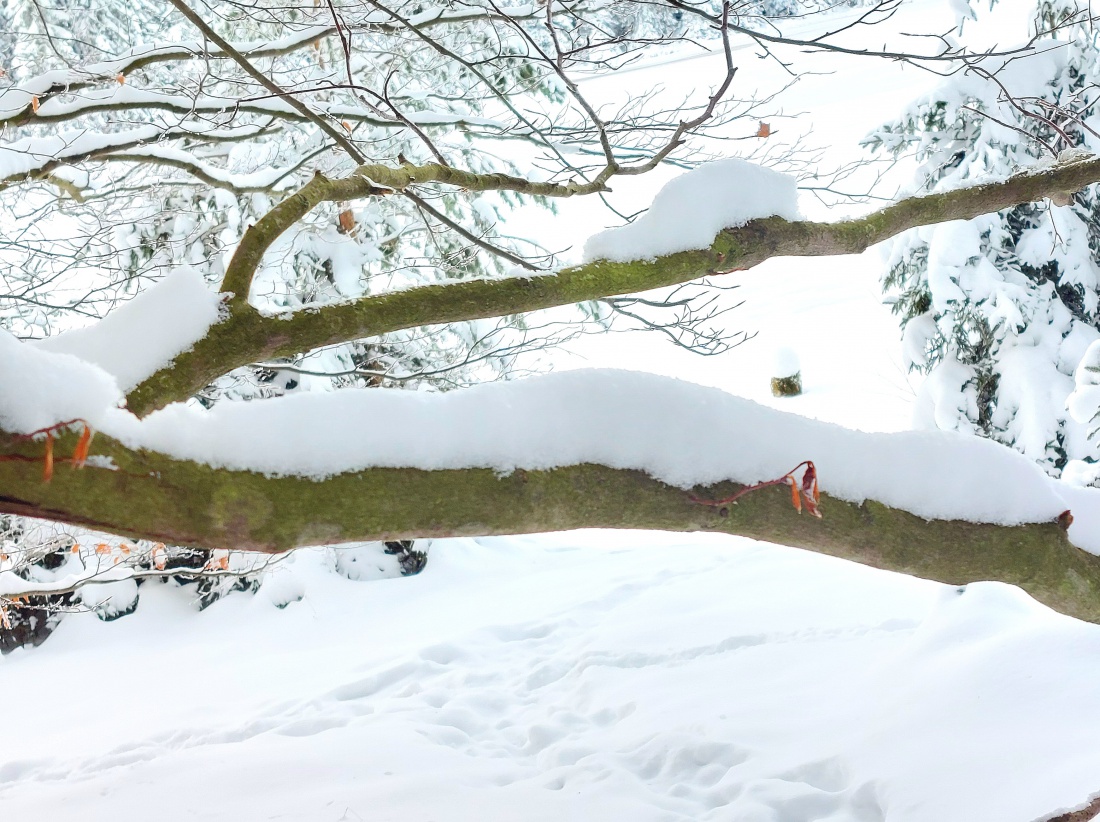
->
[0,435,1100,622]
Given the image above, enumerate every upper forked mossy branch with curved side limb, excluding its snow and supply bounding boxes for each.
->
[128,150,1100,416]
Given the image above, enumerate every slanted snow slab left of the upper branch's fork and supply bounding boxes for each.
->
[35,268,221,392]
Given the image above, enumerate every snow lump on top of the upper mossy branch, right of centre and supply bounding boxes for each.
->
[584,158,801,262]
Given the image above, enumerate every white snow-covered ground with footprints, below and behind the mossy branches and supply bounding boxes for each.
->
[0,2,1100,822]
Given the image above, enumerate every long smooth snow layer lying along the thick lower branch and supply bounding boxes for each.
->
[108,370,1068,524]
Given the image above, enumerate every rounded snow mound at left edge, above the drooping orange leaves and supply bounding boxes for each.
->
[0,329,121,434]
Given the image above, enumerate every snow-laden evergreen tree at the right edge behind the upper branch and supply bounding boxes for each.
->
[868,0,1100,483]
